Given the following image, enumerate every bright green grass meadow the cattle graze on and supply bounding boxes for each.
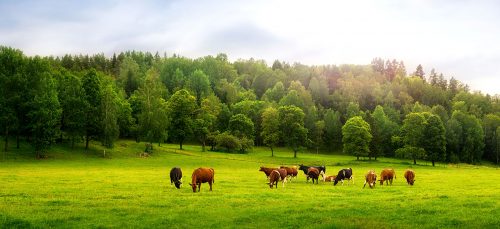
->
[0,141,500,228]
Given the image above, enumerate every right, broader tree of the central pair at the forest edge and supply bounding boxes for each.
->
[278,106,308,158]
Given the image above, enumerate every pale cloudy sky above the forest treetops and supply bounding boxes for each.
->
[0,0,500,94]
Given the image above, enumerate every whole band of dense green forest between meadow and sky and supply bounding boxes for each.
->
[0,46,500,165]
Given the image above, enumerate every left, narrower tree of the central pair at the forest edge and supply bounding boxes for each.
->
[261,107,281,157]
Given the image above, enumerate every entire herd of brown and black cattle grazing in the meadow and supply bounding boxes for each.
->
[170,165,415,192]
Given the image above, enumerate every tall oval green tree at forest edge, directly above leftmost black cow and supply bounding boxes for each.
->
[168,89,196,149]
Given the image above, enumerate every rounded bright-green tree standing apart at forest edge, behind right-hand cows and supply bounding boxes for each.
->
[342,116,372,160]
